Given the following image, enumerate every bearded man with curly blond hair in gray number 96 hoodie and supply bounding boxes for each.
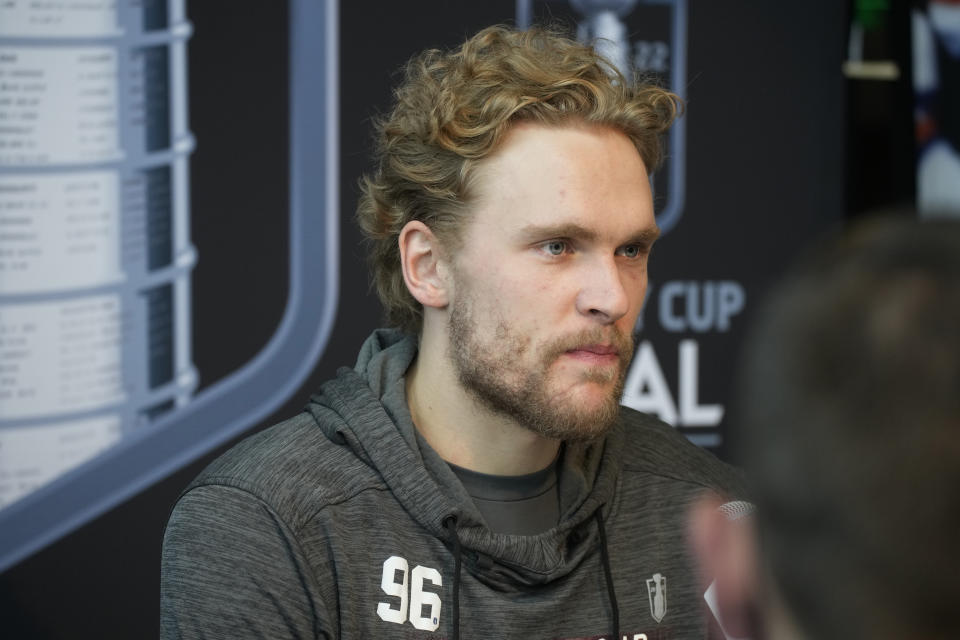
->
[162,28,738,639]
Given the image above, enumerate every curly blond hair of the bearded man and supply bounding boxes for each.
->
[357,26,682,334]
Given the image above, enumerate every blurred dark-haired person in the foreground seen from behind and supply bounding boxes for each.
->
[692,219,960,640]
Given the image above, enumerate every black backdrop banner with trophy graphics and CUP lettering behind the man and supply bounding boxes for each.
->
[0,0,844,638]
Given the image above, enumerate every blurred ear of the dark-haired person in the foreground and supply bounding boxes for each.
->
[689,493,760,638]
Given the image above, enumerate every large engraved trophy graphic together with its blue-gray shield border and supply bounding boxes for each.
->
[0,0,339,571]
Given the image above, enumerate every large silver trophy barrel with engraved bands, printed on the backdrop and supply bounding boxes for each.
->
[0,0,197,507]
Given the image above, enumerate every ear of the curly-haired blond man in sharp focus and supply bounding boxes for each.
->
[397,220,449,308]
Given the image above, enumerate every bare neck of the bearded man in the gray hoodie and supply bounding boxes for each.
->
[406,336,560,475]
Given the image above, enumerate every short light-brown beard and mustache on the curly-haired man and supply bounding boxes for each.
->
[447,298,633,442]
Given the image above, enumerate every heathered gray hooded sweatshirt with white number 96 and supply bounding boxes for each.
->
[161,331,742,640]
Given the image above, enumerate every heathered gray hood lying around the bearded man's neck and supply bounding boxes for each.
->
[307,330,624,590]
